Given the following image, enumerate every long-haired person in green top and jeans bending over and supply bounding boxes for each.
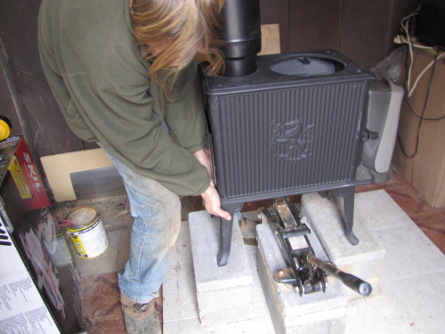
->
[38,0,231,333]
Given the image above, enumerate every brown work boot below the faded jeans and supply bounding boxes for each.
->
[121,293,162,334]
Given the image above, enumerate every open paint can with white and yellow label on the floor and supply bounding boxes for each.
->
[66,207,109,258]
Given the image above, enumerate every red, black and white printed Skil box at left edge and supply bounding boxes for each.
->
[0,136,81,334]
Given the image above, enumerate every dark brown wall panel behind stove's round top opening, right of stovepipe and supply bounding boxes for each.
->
[288,0,418,68]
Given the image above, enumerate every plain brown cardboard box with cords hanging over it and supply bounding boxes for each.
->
[393,50,445,207]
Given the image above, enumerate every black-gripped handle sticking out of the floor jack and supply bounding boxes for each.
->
[307,253,372,296]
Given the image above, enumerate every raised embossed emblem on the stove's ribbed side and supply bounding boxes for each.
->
[271,120,315,160]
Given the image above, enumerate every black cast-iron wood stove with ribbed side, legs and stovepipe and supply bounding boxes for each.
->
[203,0,373,266]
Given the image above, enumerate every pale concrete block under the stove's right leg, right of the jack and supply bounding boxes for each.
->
[301,193,386,298]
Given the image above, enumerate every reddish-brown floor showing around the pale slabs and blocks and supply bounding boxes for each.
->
[81,169,445,334]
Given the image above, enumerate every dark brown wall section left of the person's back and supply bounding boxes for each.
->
[0,0,92,160]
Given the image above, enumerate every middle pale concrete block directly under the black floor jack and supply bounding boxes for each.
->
[257,220,348,334]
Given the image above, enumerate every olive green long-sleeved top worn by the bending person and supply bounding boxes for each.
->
[38,0,210,195]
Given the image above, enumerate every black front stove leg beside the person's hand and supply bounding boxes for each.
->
[217,203,244,266]
